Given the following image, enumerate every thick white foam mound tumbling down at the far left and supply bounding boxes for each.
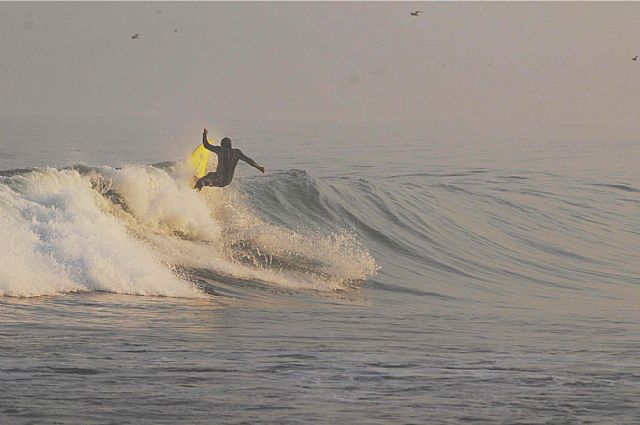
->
[0,169,201,297]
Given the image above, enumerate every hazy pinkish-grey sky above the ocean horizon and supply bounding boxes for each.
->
[0,2,640,127]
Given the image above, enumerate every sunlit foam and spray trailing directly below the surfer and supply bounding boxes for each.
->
[110,167,377,290]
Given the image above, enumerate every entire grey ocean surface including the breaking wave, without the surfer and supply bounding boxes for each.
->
[0,116,640,424]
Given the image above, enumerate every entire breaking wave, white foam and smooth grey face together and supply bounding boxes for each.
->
[0,154,640,302]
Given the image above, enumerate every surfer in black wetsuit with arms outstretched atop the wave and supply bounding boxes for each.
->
[195,128,264,190]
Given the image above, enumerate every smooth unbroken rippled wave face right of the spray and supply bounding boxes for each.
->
[350,169,640,302]
